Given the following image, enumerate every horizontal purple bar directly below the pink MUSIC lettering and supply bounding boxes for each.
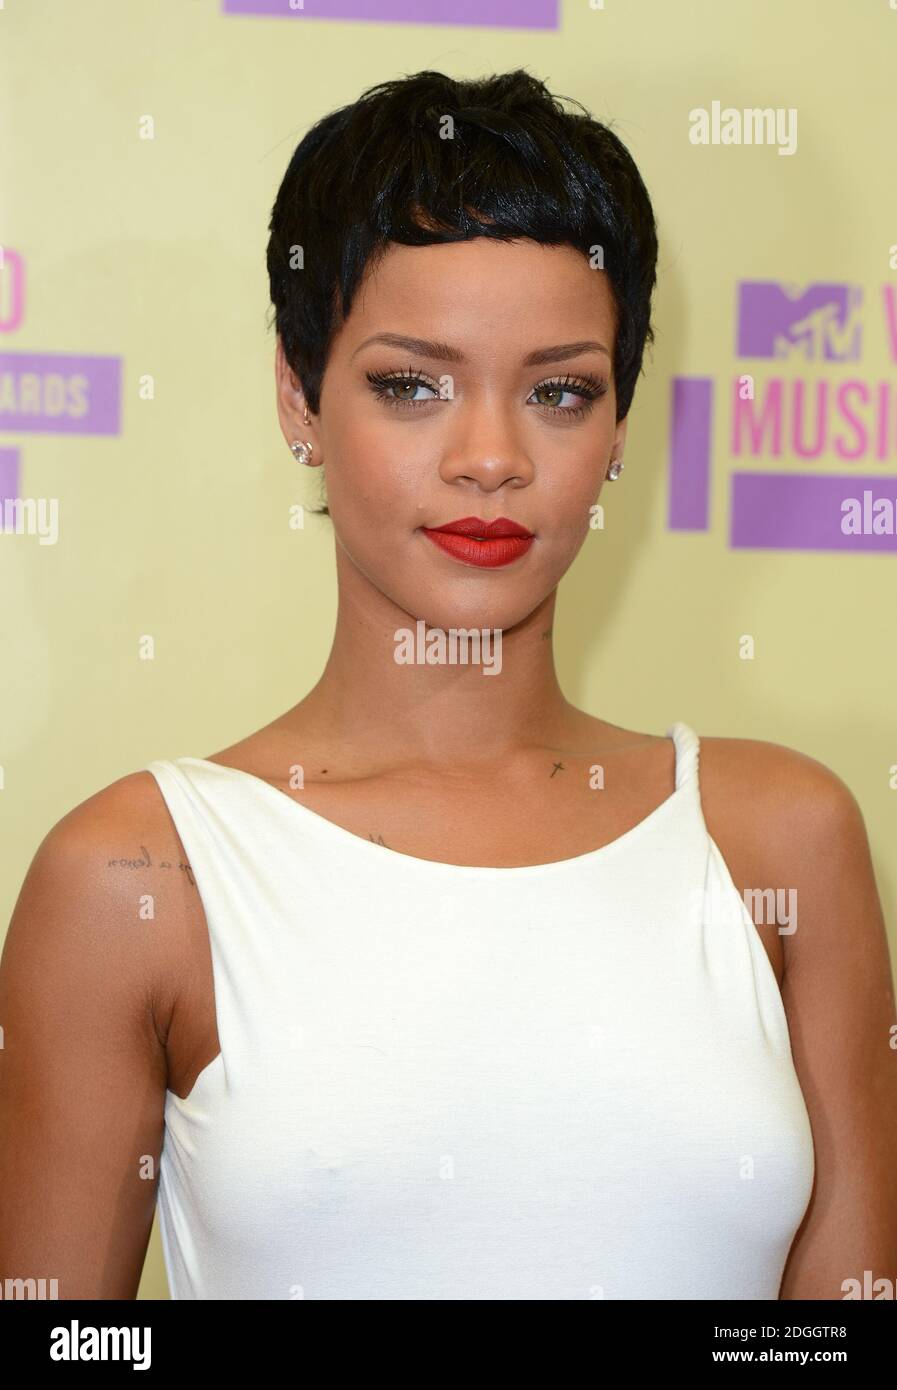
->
[729,473,897,555]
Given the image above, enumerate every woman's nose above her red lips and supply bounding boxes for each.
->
[439,398,535,492]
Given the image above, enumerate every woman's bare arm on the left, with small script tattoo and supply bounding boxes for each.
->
[0,773,177,1298]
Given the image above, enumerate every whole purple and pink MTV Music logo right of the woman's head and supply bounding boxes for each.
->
[669,281,897,555]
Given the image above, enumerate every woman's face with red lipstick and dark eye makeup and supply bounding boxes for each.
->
[277,238,626,630]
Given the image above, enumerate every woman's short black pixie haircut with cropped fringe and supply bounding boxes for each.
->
[267,68,658,511]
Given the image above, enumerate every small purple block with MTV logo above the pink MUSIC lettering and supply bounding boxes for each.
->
[736,279,862,361]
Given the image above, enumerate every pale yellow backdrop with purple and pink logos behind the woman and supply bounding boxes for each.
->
[0,0,897,1297]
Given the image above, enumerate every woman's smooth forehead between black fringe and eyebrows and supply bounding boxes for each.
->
[341,236,615,354]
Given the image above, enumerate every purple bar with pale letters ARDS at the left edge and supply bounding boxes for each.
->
[0,352,121,435]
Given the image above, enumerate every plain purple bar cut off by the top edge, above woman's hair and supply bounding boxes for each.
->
[221,0,559,29]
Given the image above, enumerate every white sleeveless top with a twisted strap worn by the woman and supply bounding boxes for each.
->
[146,723,814,1301]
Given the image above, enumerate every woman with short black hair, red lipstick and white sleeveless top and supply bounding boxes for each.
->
[0,71,897,1300]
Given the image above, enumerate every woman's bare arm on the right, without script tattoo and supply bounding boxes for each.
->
[777,755,897,1300]
